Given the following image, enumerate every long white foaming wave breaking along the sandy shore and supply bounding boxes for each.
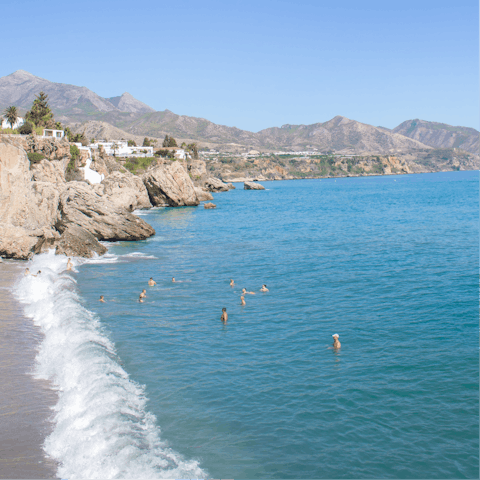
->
[15,253,207,479]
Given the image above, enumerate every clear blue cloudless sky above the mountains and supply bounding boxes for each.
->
[0,0,479,131]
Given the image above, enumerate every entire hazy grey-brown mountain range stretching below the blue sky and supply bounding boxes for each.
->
[0,70,479,155]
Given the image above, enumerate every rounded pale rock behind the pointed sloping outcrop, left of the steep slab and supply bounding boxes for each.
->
[101,171,152,212]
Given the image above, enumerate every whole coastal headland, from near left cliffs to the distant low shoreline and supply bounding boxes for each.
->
[0,128,478,260]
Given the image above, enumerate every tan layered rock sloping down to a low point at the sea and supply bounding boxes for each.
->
[55,182,155,240]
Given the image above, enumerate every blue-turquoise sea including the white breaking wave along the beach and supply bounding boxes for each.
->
[15,171,479,480]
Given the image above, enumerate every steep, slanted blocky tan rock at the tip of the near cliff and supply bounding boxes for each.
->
[142,162,200,207]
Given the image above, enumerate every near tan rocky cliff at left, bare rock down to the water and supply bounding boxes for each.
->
[0,136,204,259]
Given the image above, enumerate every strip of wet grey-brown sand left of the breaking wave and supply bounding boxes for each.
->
[0,261,57,479]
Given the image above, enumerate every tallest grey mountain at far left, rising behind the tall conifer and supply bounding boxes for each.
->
[0,70,154,122]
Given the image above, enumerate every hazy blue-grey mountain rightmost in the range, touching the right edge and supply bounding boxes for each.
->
[392,118,479,155]
